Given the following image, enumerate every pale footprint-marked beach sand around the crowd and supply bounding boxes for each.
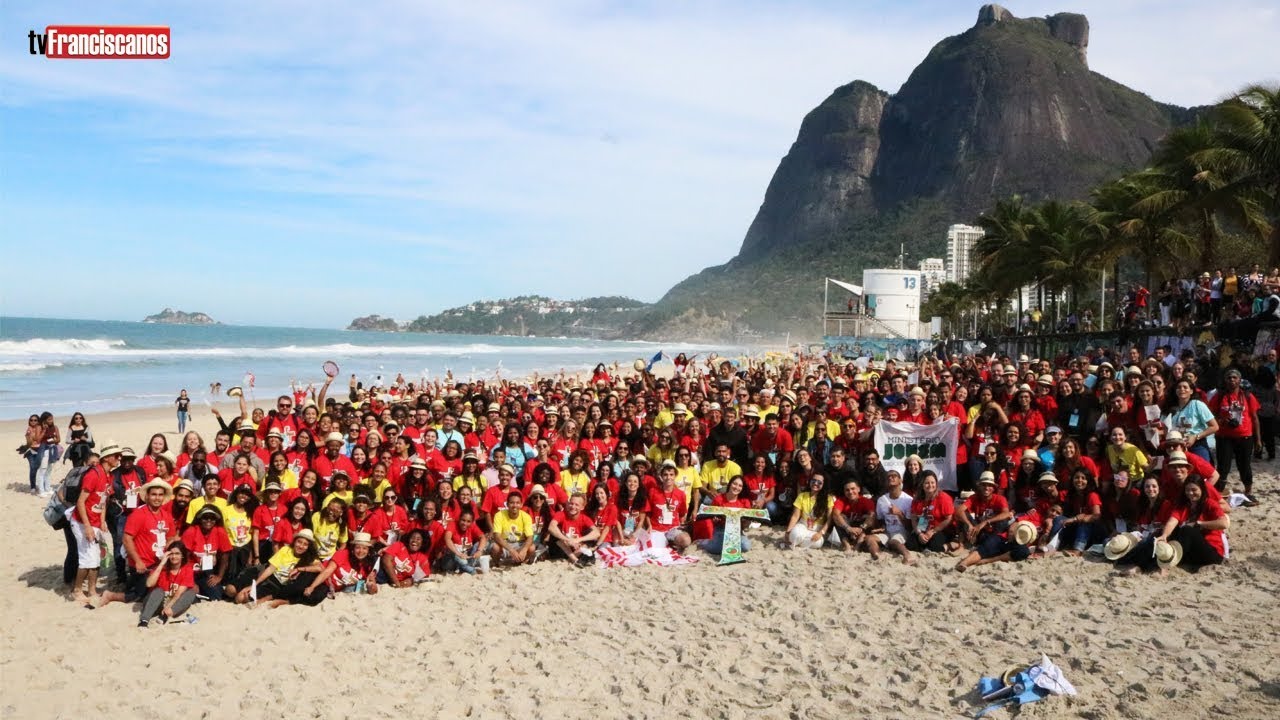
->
[0,410,1280,719]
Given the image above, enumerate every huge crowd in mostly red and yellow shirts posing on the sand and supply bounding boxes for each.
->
[20,335,1280,625]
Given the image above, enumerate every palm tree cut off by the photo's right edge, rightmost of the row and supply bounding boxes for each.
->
[1213,85,1280,268]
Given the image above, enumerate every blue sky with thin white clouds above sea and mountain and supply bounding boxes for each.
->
[0,0,1280,327]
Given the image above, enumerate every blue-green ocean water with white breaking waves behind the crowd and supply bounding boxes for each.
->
[0,318,736,420]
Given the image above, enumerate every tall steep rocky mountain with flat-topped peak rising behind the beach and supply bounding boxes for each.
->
[632,5,1194,337]
